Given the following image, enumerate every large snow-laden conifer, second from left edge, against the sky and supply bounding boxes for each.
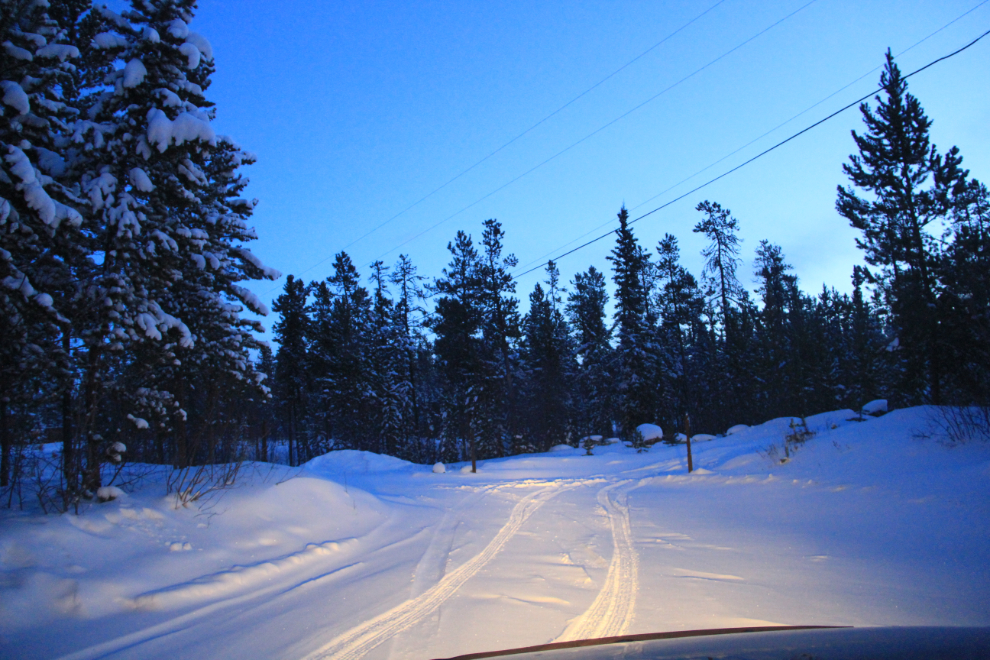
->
[66,0,279,490]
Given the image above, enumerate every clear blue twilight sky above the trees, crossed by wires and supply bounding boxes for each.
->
[193,0,990,338]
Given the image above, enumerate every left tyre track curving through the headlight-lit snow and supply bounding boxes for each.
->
[305,483,578,660]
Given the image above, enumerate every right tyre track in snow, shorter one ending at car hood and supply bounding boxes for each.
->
[554,481,639,642]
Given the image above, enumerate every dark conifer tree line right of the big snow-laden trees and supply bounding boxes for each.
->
[264,52,990,463]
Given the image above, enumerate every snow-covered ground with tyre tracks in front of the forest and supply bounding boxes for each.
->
[0,409,990,660]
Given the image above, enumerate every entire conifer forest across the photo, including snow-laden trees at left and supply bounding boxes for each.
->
[0,0,990,510]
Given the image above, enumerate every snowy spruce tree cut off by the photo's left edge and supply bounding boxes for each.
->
[0,0,82,491]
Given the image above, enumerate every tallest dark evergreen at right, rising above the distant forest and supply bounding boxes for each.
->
[836,50,967,403]
